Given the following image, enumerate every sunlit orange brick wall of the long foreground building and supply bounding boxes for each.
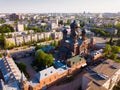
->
[31,61,86,90]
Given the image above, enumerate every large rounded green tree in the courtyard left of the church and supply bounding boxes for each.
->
[36,50,53,67]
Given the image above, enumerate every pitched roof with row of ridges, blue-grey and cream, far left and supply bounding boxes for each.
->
[0,57,21,83]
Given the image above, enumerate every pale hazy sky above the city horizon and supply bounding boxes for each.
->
[0,0,120,13]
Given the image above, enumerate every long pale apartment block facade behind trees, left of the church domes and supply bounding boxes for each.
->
[6,32,62,46]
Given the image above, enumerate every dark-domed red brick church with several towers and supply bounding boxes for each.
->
[59,20,88,60]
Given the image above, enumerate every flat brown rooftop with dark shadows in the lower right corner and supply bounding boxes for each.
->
[84,59,120,87]
